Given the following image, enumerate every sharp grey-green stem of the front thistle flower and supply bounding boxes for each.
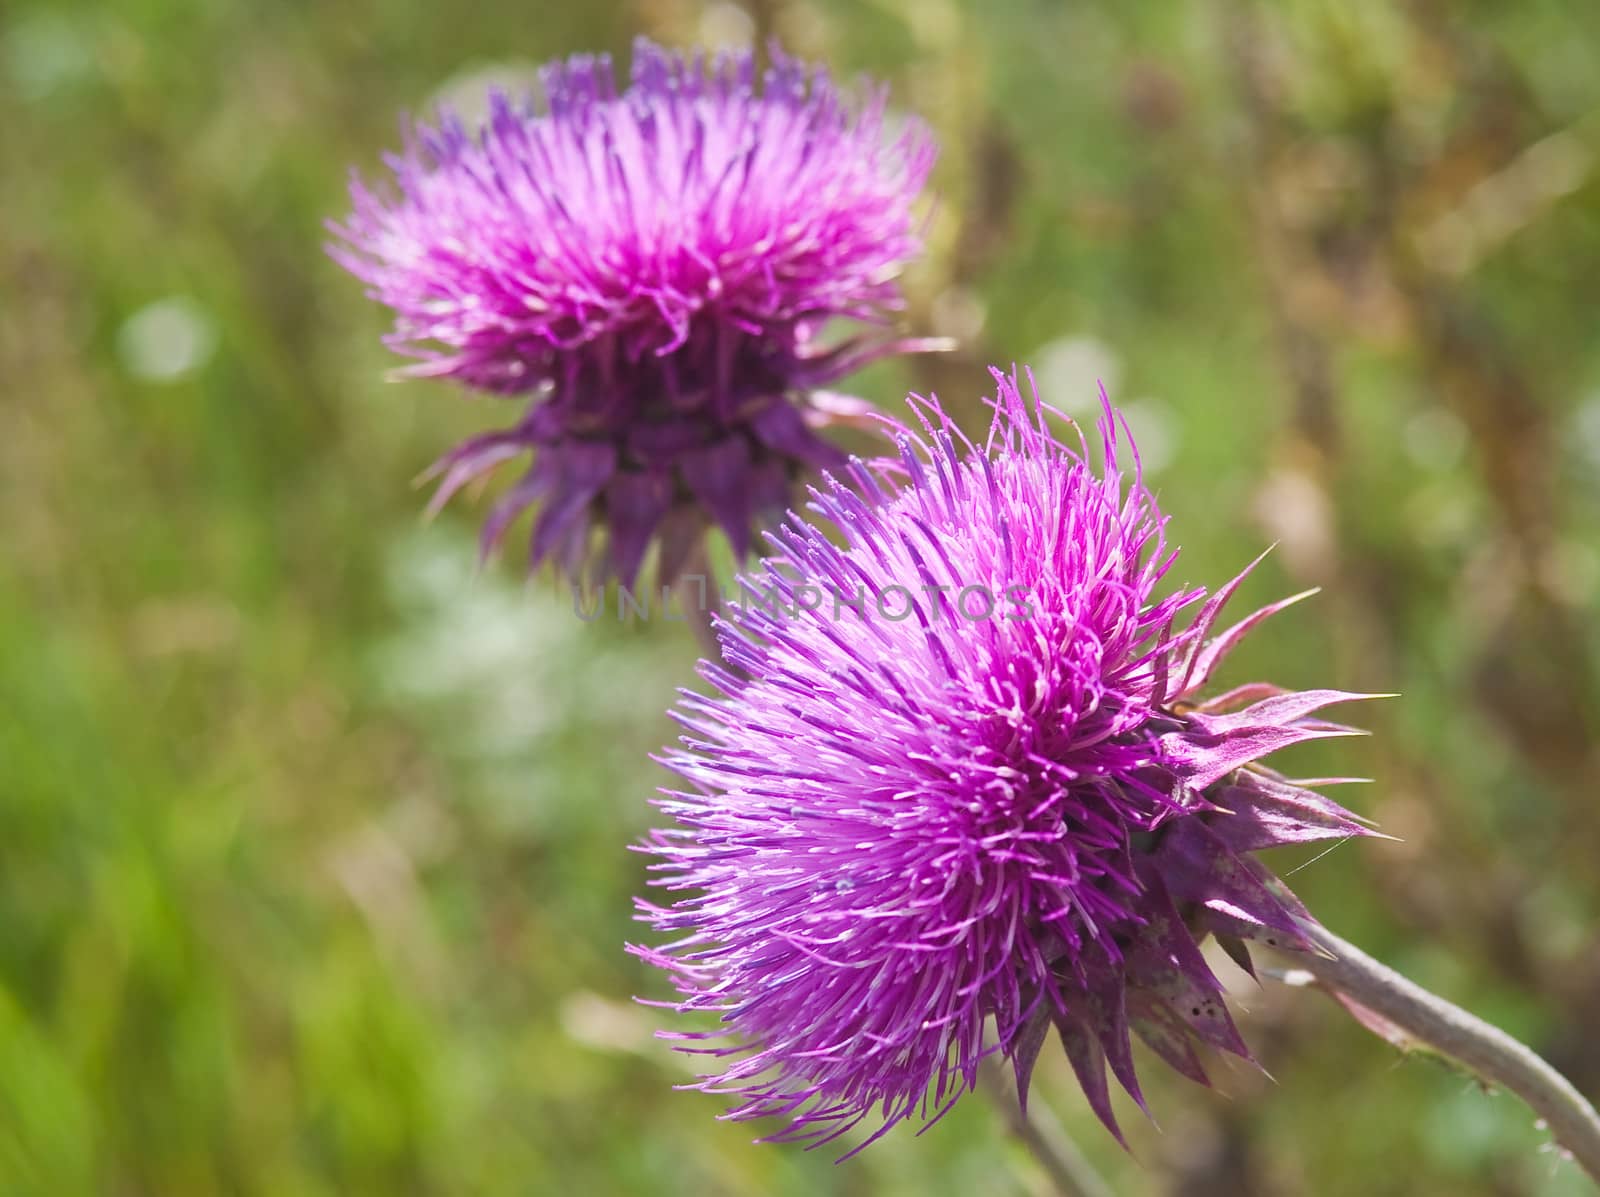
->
[1283,925,1600,1181]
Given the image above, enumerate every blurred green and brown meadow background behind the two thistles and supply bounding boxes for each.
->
[0,0,1600,1197]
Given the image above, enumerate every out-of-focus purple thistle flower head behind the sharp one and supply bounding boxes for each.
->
[331,40,938,584]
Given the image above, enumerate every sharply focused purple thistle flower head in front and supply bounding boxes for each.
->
[632,371,1366,1143]
